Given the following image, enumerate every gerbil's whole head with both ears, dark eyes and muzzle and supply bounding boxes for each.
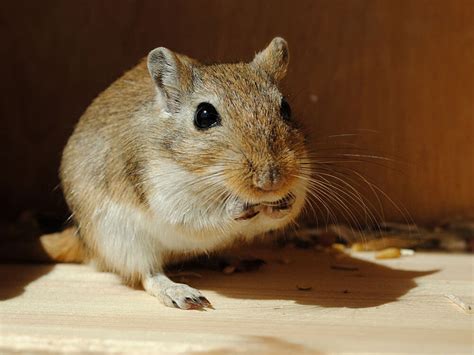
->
[148,37,307,234]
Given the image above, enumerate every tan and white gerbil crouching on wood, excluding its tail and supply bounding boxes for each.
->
[60,38,307,309]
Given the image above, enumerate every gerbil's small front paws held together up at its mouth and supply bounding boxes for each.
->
[234,192,296,221]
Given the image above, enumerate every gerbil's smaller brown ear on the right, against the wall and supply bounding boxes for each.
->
[251,37,290,81]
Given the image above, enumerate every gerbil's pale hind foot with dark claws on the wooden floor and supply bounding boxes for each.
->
[143,273,211,309]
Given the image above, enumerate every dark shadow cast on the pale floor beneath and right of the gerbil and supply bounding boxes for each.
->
[169,249,438,308]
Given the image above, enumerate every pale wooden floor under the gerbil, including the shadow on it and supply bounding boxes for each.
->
[0,247,474,354]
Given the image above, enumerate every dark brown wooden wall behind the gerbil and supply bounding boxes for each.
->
[0,0,474,222]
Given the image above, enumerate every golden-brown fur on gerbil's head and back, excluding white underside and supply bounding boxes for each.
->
[55,38,306,290]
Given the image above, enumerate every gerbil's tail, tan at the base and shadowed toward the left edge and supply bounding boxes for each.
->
[0,227,86,263]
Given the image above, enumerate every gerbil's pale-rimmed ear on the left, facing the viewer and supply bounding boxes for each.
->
[148,47,197,112]
